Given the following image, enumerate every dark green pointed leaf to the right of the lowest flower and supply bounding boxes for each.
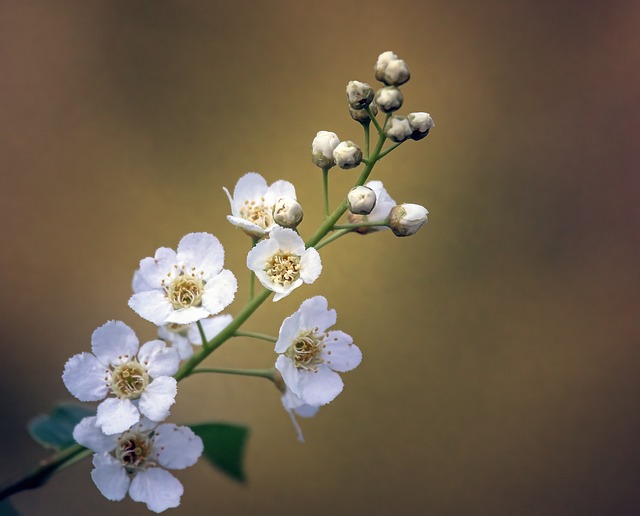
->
[189,423,249,482]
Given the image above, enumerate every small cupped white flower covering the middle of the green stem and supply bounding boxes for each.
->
[247,227,322,301]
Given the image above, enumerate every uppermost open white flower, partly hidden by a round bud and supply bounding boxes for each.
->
[223,172,296,238]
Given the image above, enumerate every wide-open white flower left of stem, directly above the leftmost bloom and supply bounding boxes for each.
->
[129,233,238,326]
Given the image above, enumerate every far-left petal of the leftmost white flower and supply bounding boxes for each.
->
[62,353,109,401]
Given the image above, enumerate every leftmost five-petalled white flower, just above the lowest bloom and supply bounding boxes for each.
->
[62,321,180,434]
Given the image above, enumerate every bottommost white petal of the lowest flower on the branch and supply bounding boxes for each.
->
[129,468,184,512]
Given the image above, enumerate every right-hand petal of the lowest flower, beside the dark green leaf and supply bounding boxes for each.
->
[153,424,204,469]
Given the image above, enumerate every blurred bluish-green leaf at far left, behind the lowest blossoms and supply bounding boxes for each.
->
[27,403,95,450]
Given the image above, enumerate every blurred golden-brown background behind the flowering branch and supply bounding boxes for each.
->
[0,0,640,515]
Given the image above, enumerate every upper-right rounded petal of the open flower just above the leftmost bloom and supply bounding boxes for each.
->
[177,233,224,281]
